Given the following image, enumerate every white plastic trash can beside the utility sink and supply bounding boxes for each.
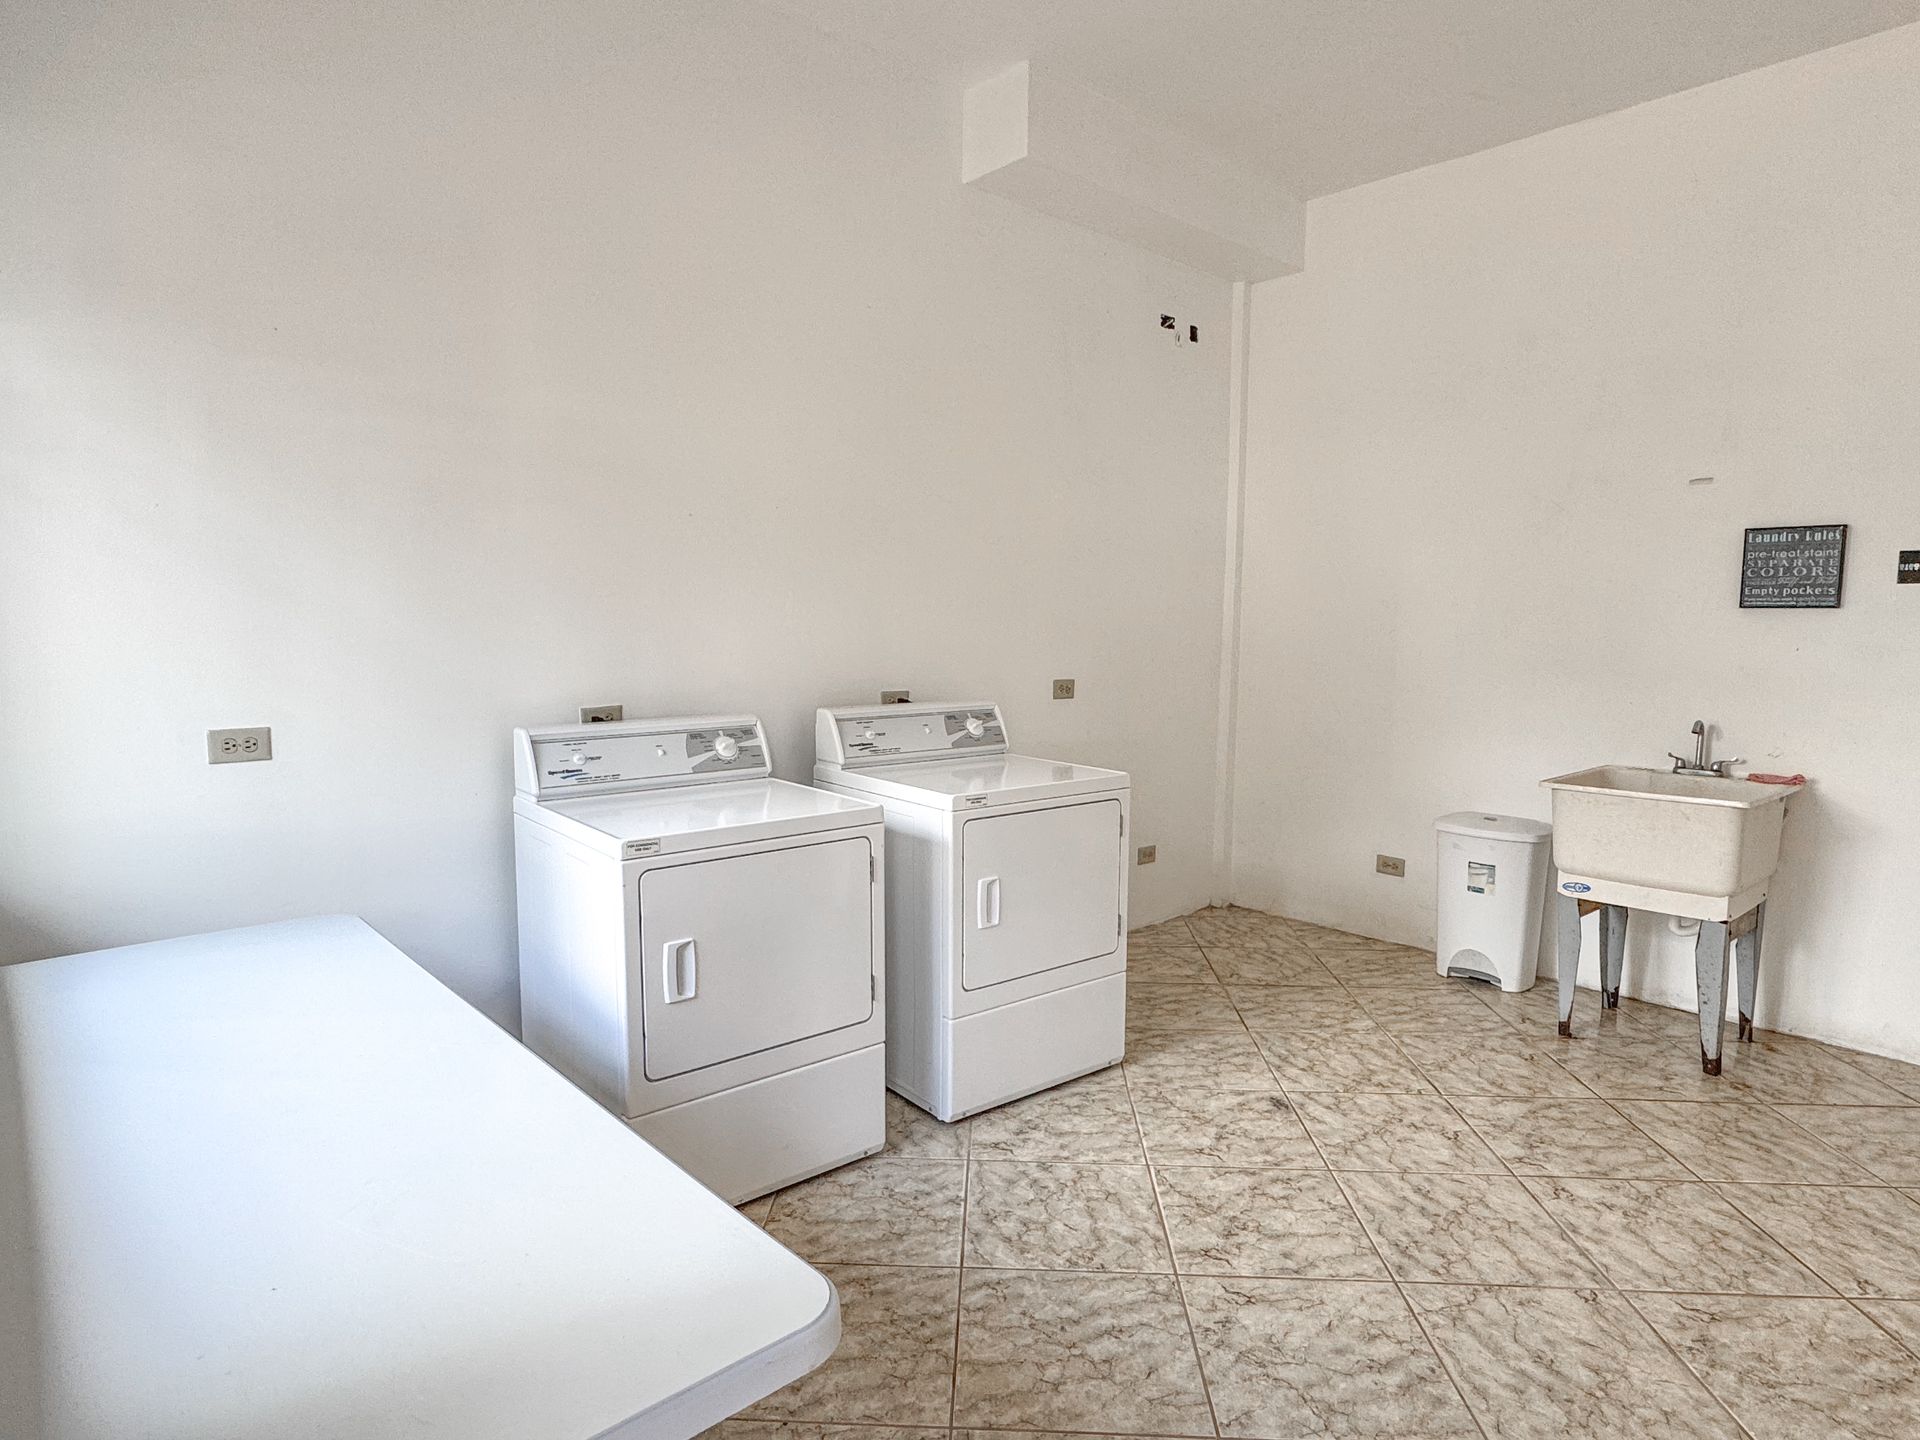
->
[1434,810,1553,991]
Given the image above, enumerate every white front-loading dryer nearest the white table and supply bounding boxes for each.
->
[513,716,887,1223]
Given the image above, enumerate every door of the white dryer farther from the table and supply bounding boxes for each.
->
[960,801,1121,991]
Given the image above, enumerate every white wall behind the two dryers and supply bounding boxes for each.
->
[0,0,1227,1023]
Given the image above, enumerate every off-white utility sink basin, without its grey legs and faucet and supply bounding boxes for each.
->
[1540,764,1793,897]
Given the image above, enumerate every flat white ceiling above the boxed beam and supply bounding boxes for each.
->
[770,0,1920,198]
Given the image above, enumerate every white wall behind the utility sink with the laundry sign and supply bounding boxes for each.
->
[1235,27,1920,1060]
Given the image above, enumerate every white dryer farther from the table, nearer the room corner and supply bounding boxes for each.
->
[814,705,1129,1119]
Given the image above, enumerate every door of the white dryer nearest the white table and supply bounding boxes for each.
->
[637,835,874,1081]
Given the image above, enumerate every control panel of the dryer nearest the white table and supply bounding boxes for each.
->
[513,714,774,799]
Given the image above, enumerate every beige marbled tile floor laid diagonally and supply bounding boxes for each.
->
[714,910,1920,1440]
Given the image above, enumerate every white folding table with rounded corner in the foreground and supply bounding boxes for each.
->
[0,916,839,1440]
